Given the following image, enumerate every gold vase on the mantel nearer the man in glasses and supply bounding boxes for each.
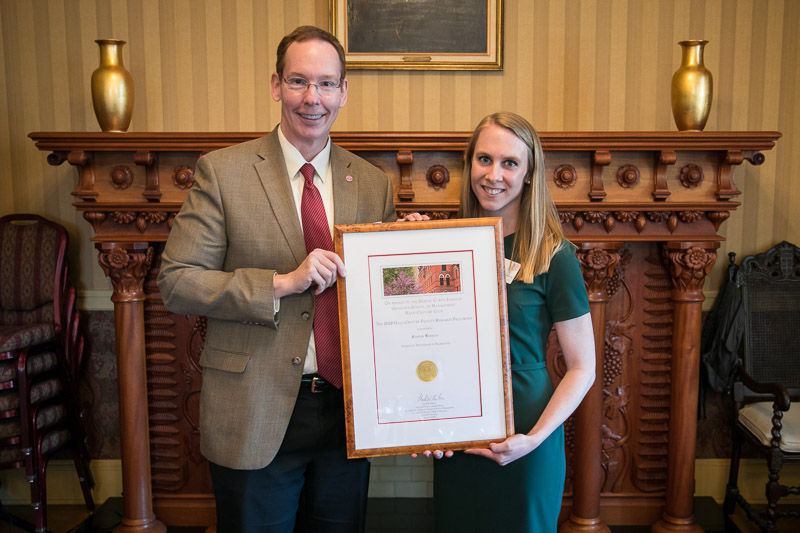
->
[92,39,133,132]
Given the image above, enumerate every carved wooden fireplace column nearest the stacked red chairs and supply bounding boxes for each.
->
[96,242,167,533]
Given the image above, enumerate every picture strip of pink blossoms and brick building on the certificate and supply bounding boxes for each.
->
[383,263,461,296]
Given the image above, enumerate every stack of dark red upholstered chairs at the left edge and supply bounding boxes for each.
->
[0,215,94,531]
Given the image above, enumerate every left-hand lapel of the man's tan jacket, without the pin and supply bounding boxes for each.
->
[255,127,307,265]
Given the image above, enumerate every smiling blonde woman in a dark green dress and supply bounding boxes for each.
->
[433,113,595,533]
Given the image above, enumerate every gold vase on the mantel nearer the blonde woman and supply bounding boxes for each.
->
[672,41,713,131]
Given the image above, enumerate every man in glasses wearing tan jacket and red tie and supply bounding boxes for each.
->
[158,26,395,533]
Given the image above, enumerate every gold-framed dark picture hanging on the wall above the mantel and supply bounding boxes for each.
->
[330,0,503,70]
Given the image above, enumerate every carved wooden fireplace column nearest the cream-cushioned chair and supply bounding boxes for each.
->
[652,242,719,533]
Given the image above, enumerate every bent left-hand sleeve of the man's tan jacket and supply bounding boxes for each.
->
[158,157,277,328]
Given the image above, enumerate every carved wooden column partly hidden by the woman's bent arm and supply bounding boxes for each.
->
[558,242,622,533]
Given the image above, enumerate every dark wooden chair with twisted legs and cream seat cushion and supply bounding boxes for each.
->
[723,241,800,531]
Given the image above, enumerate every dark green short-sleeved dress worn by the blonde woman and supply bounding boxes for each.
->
[434,235,589,533]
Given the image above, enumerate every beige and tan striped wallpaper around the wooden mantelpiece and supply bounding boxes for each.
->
[0,0,800,291]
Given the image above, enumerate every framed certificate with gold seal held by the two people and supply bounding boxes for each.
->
[334,218,514,458]
